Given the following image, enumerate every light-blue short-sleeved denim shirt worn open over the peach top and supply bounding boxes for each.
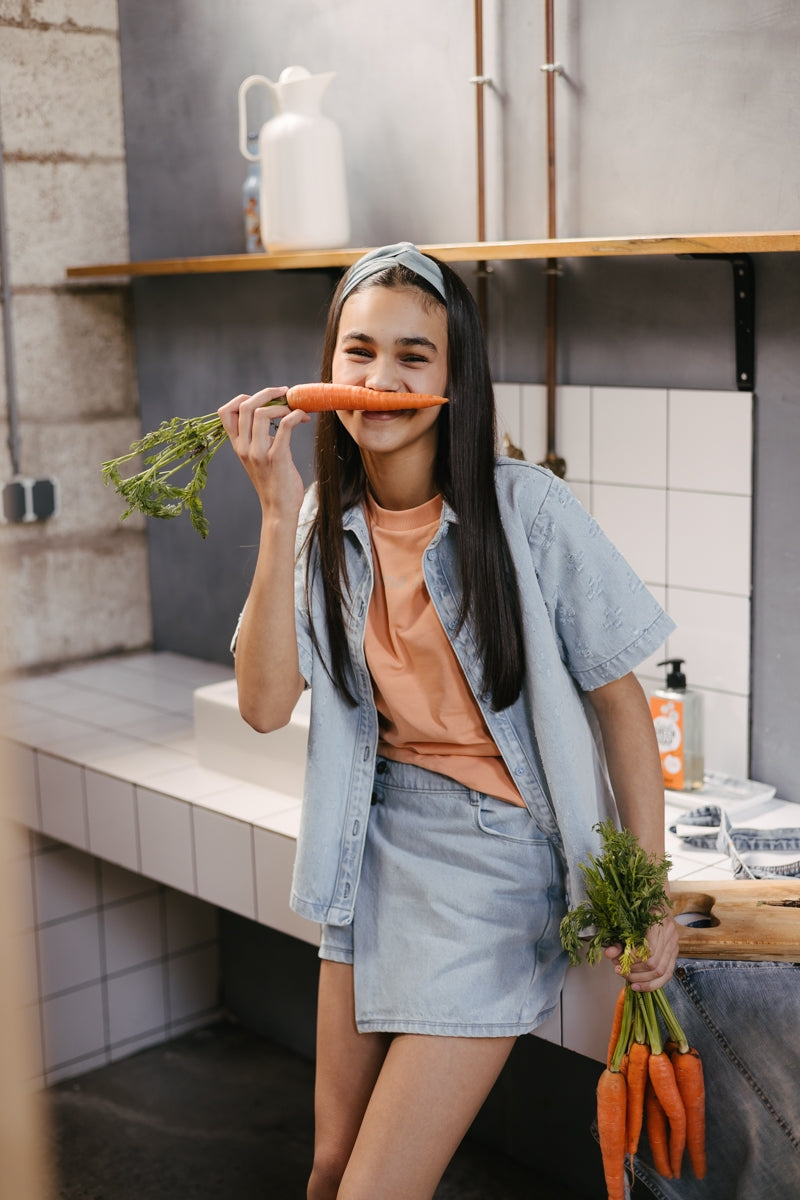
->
[284,458,674,925]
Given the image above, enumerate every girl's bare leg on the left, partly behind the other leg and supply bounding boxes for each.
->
[308,960,391,1200]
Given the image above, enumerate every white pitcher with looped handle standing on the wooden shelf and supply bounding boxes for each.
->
[239,67,350,251]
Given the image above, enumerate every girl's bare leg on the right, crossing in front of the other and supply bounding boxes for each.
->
[336,1033,515,1200]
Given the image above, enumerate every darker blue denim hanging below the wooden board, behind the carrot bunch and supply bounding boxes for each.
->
[633,959,800,1200]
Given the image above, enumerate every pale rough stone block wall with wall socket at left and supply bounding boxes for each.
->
[0,0,151,670]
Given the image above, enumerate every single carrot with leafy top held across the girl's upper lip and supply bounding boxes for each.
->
[101,383,446,538]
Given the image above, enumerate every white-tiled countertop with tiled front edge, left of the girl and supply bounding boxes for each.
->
[1,653,319,943]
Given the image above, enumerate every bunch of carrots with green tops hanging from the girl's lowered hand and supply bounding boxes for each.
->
[561,821,705,1200]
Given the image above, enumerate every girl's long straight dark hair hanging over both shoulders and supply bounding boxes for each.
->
[307,248,525,710]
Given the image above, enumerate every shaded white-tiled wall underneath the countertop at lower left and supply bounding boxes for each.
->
[13,829,219,1084]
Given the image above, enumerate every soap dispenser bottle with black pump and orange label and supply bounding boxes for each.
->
[650,659,705,792]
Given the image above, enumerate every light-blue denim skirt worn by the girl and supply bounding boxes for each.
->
[319,758,567,1037]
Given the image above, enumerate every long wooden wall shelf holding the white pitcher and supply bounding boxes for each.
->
[66,232,800,280]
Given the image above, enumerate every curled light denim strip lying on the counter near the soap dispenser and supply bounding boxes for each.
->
[669,804,800,880]
